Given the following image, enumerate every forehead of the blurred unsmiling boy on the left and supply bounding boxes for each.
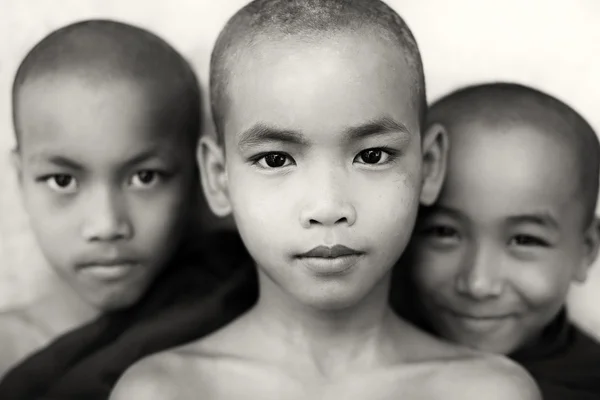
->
[15,76,183,152]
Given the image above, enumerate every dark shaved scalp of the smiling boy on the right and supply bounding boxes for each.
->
[427,83,600,221]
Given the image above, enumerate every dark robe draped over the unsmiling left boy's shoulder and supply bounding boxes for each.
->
[0,232,257,400]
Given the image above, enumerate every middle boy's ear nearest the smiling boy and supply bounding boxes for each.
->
[420,123,448,206]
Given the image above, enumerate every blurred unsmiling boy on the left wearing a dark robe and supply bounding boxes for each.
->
[0,20,255,399]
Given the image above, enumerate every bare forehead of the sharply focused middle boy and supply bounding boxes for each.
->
[225,33,419,142]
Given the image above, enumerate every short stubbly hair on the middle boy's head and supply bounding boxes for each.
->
[210,0,427,138]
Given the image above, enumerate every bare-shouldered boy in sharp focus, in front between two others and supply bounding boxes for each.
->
[112,0,538,400]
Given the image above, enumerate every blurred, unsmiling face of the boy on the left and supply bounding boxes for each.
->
[14,75,194,310]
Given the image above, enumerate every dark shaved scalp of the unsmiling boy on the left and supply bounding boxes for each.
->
[12,20,200,148]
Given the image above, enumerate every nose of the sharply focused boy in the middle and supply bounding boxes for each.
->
[300,170,356,228]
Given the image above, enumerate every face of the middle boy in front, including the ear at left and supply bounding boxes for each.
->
[200,34,435,309]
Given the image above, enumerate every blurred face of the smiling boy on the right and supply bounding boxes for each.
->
[414,121,583,354]
